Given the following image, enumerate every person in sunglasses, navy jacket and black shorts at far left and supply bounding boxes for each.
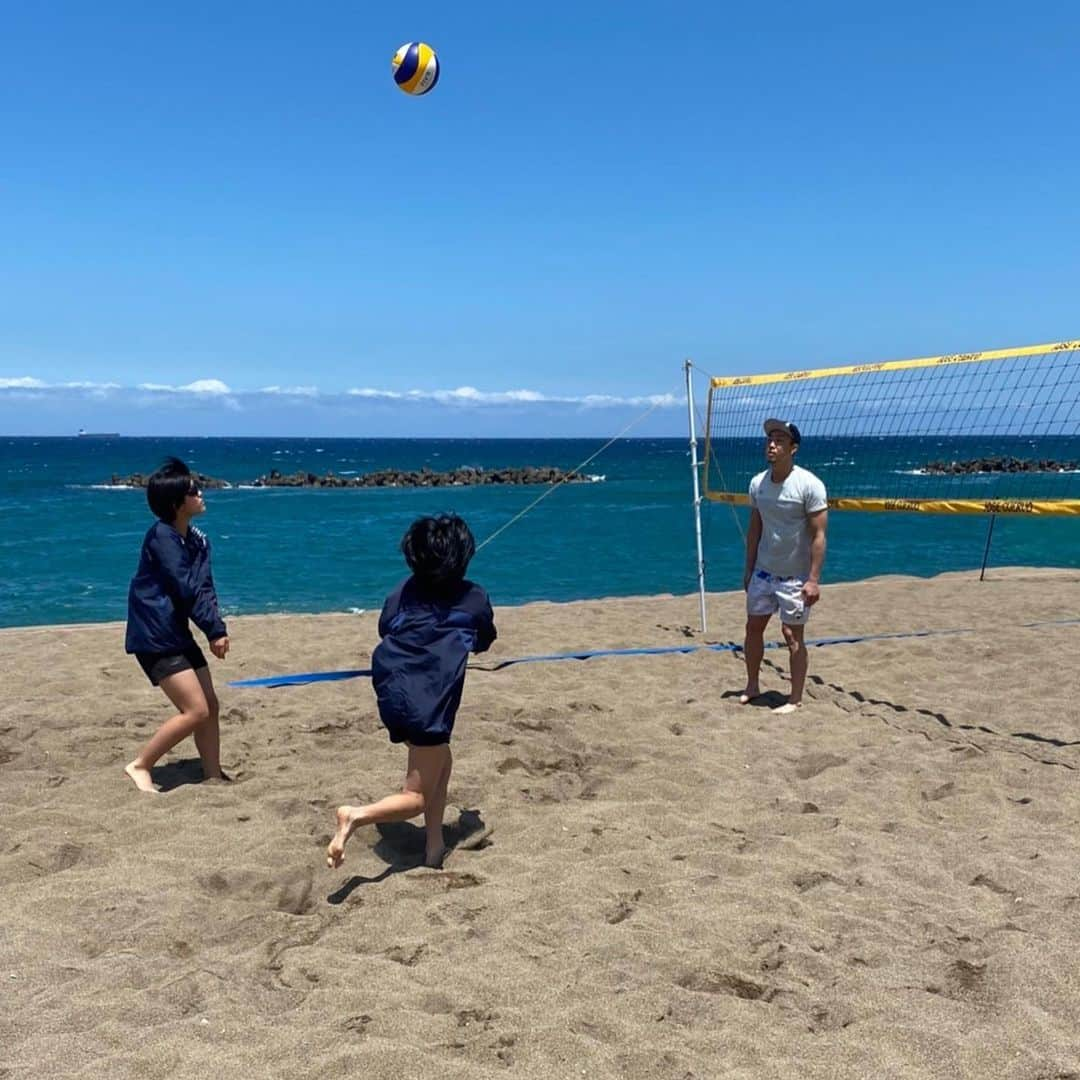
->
[124,458,229,793]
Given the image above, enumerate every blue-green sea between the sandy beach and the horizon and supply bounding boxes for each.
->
[0,437,1080,626]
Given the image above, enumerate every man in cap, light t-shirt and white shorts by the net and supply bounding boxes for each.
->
[739,419,828,714]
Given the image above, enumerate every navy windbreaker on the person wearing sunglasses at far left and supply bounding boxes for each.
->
[125,522,226,652]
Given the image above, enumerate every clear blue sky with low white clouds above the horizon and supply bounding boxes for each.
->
[0,0,1080,436]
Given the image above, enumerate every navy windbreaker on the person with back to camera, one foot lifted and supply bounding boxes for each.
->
[372,578,497,746]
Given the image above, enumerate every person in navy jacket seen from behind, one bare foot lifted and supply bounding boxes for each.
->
[326,514,497,868]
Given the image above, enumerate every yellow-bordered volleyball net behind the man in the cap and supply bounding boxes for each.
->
[702,340,1080,516]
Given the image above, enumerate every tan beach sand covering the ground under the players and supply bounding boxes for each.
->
[0,569,1080,1080]
